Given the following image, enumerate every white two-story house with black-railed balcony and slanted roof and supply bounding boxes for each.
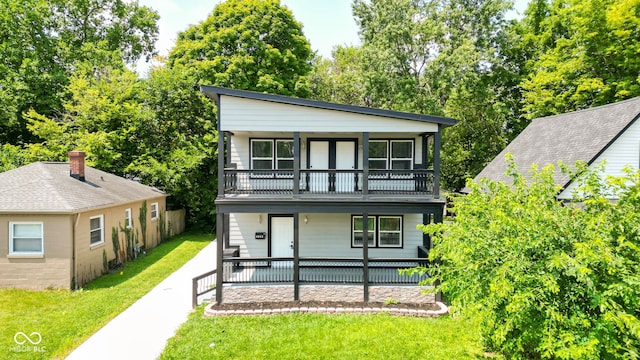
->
[202,86,456,301]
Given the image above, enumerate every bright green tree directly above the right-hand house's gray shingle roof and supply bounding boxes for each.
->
[521,0,640,118]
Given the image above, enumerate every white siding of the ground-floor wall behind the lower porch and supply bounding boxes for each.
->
[229,213,422,258]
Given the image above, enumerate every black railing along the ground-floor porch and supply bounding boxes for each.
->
[223,257,426,285]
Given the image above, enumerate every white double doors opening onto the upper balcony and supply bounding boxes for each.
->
[308,140,357,193]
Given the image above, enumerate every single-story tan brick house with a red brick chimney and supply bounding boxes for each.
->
[0,151,167,289]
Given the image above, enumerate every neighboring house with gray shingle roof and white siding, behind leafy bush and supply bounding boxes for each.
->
[475,97,640,200]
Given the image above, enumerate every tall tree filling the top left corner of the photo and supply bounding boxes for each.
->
[0,0,159,145]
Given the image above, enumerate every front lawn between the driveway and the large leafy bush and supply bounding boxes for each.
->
[161,306,484,360]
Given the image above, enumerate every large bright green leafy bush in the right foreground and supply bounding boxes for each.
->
[422,159,640,359]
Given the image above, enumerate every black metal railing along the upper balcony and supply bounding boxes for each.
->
[224,169,434,195]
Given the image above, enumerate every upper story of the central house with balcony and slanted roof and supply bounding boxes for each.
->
[202,86,456,204]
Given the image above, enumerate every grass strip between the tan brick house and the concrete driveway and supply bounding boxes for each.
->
[0,233,212,359]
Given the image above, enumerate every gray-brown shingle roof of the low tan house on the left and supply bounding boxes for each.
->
[0,162,166,213]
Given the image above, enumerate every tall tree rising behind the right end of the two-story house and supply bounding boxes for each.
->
[353,0,510,190]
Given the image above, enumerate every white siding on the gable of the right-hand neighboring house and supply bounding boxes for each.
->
[558,121,640,200]
